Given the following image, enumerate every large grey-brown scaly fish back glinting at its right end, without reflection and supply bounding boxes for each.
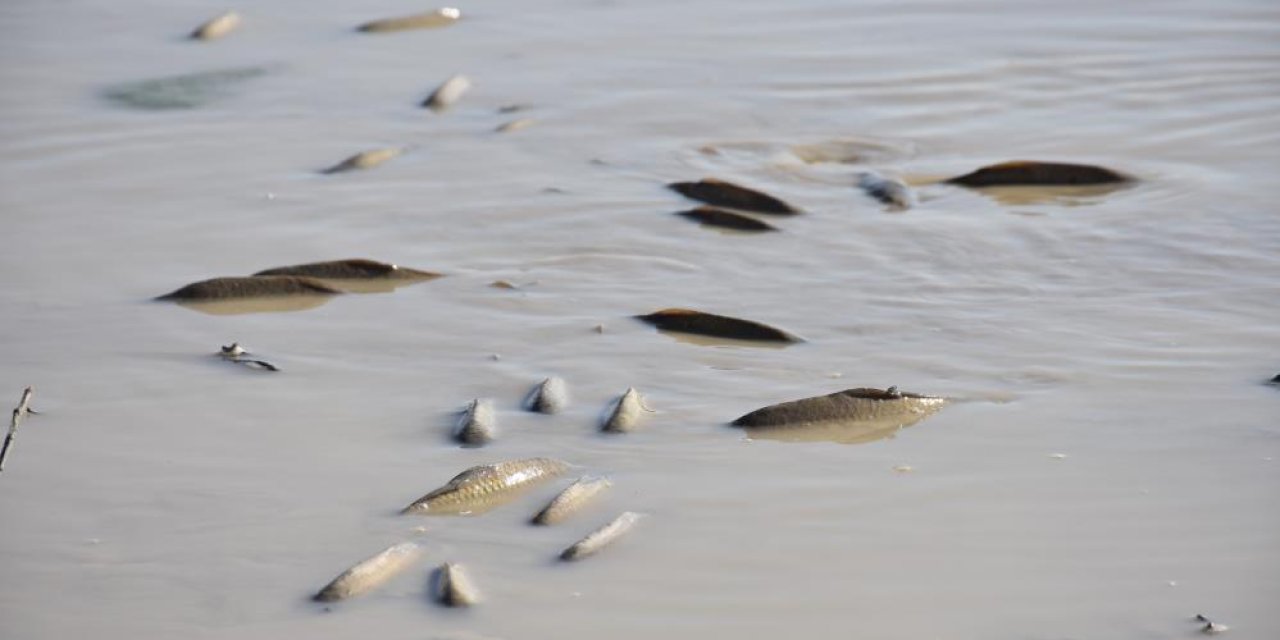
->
[732,387,947,428]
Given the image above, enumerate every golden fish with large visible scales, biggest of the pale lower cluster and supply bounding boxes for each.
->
[401,458,568,515]
